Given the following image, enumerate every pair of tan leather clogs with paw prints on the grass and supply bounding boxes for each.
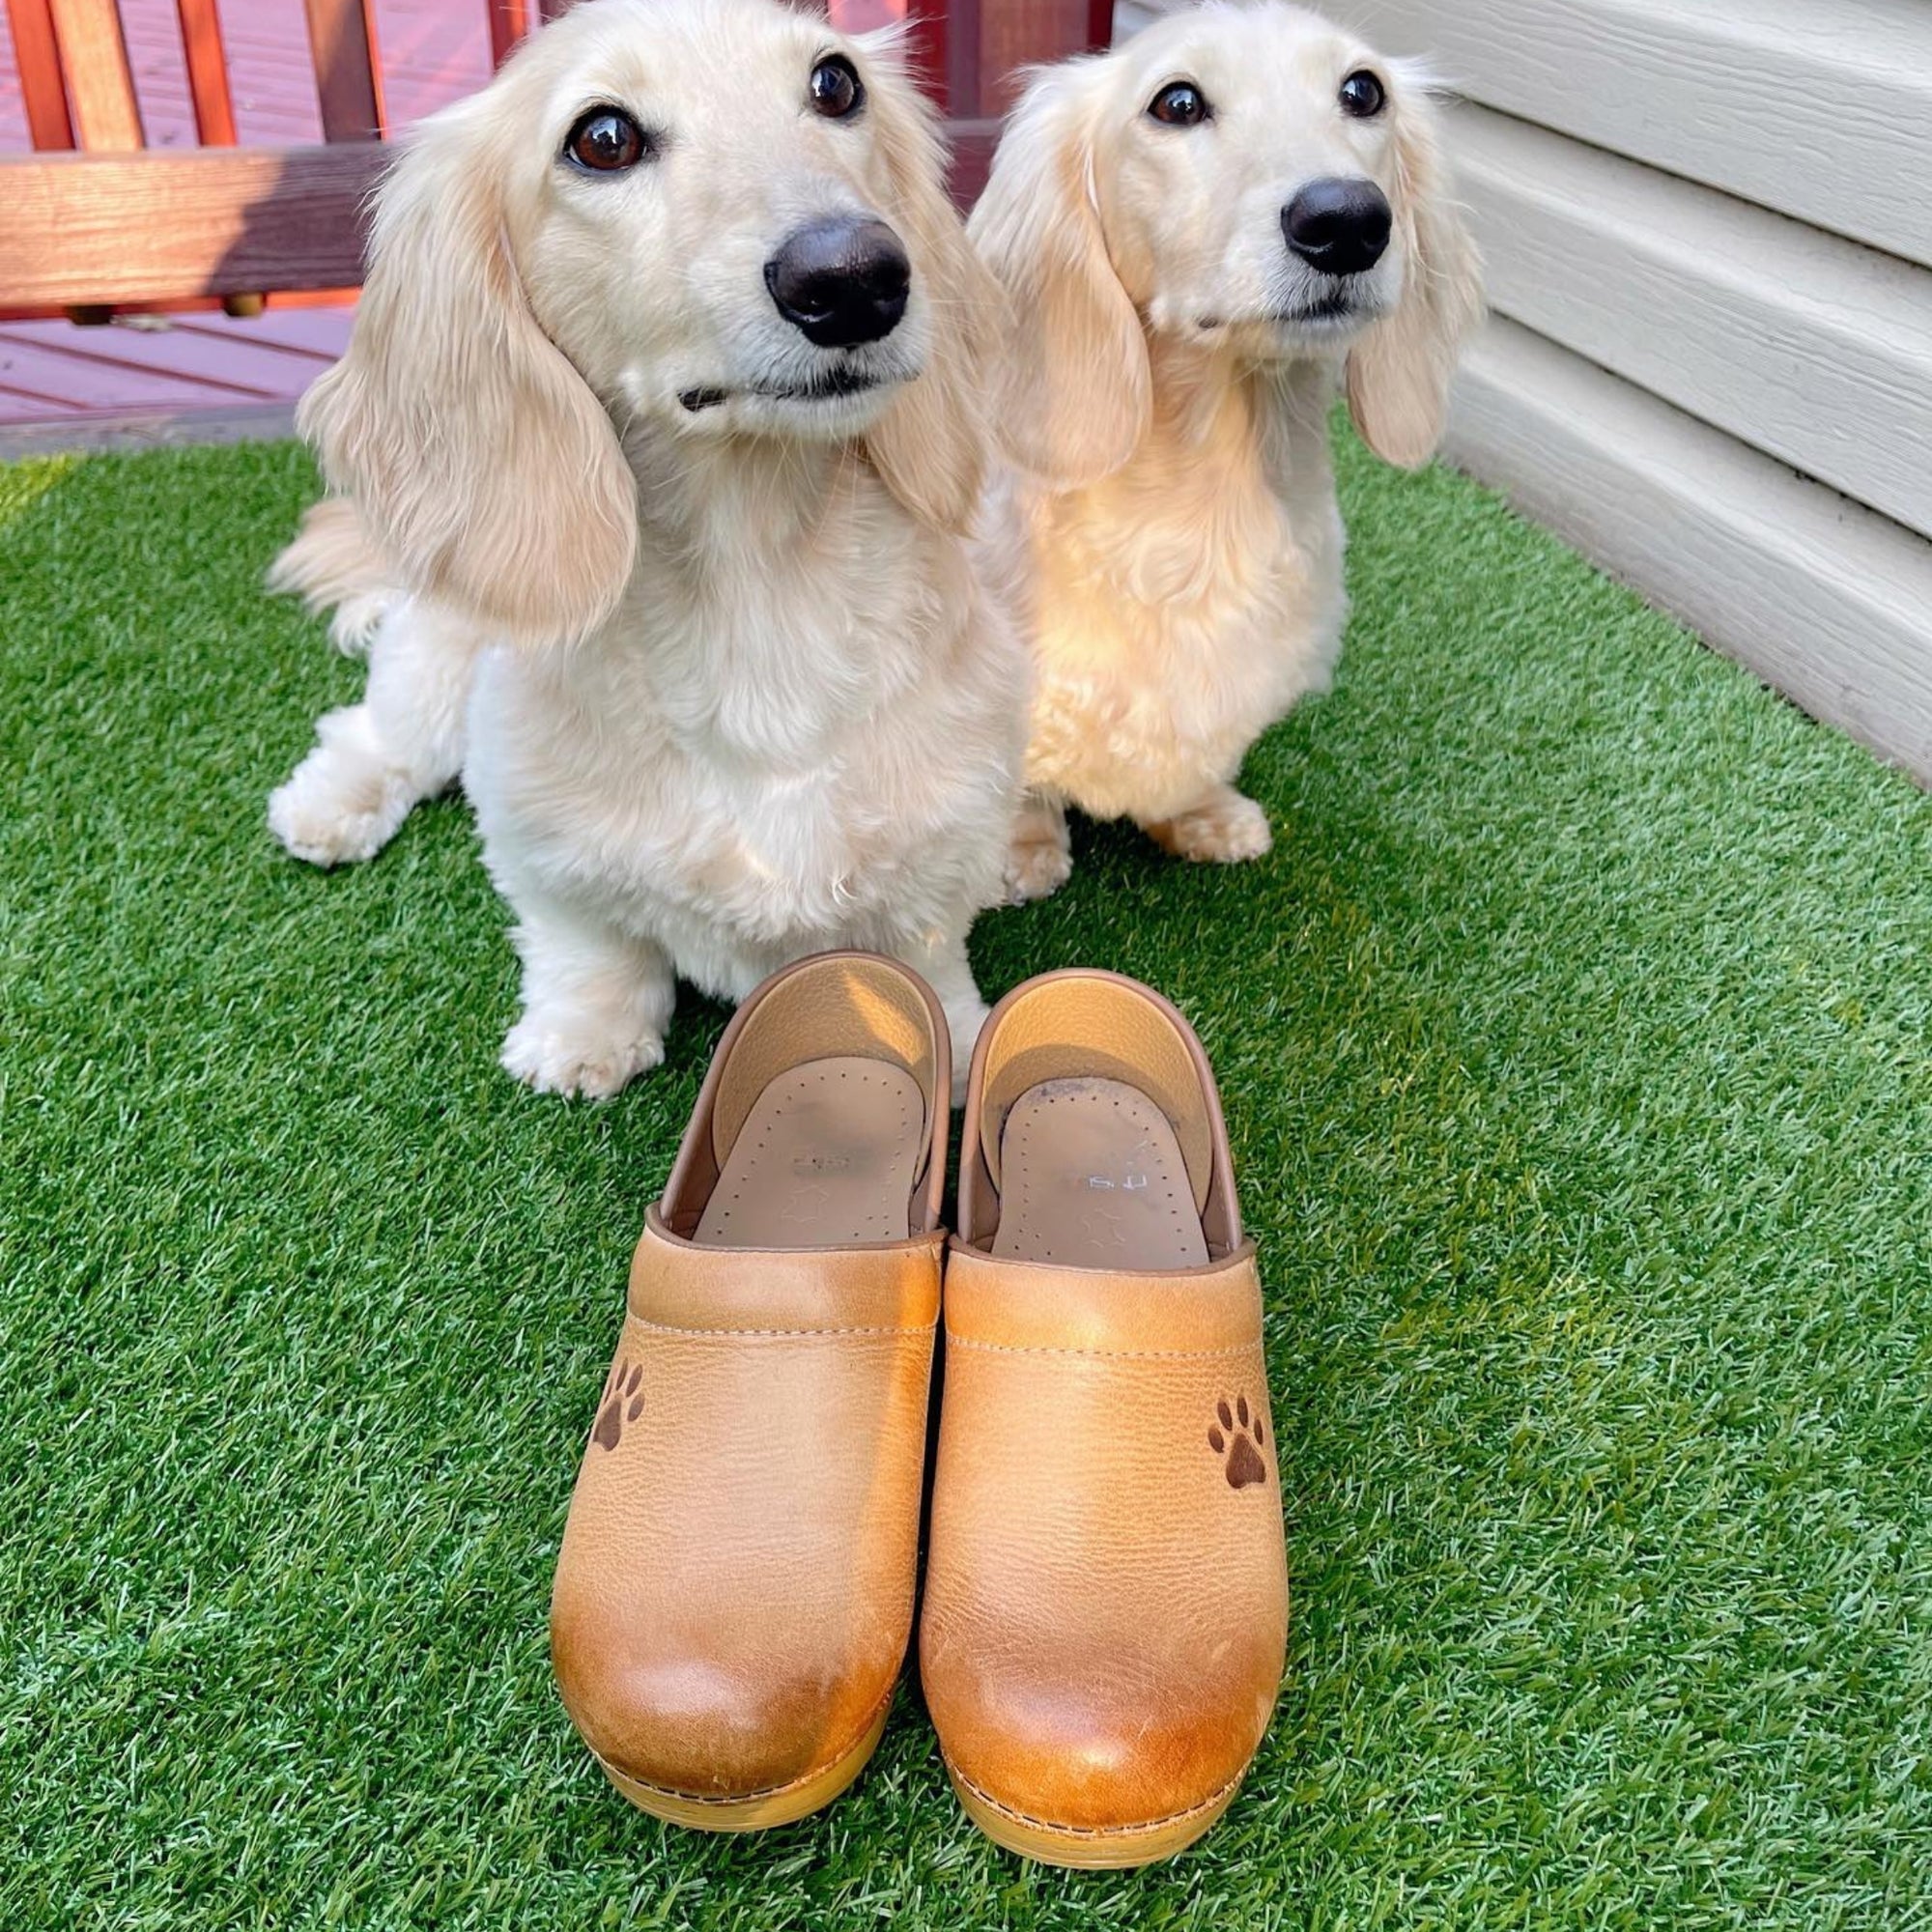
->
[551,954,1287,1866]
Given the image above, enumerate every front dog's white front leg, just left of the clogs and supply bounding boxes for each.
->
[502,893,676,1099]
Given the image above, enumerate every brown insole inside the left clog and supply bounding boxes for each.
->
[692,1055,925,1248]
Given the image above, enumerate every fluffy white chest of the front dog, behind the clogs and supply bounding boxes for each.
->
[466,506,1024,999]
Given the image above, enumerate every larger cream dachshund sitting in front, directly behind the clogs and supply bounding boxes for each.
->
[270,0,1028,1095]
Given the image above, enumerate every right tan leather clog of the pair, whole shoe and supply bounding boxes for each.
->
[920,972,1289,1866]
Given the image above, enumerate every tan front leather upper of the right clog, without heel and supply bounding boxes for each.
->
[920,1244,1289,1832]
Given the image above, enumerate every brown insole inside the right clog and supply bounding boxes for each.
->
[993,1080,1208,1271]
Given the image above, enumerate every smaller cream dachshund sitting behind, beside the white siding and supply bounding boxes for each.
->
[970,0,1482,898]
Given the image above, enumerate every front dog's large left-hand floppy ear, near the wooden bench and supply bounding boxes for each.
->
[298,89,638,639]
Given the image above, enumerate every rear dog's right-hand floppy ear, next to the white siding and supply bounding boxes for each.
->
[1349,70,1482,469]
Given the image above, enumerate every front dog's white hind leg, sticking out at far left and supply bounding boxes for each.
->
[269,599,481,866]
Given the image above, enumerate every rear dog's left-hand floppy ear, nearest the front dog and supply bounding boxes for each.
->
[968,60,1153,487]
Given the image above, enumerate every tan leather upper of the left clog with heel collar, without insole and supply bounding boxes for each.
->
[551,958,947,1801]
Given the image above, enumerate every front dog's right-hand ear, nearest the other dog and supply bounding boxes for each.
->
[866,35,1003,531]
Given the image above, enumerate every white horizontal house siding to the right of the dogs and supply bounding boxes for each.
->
[1119,0,1932,779]
